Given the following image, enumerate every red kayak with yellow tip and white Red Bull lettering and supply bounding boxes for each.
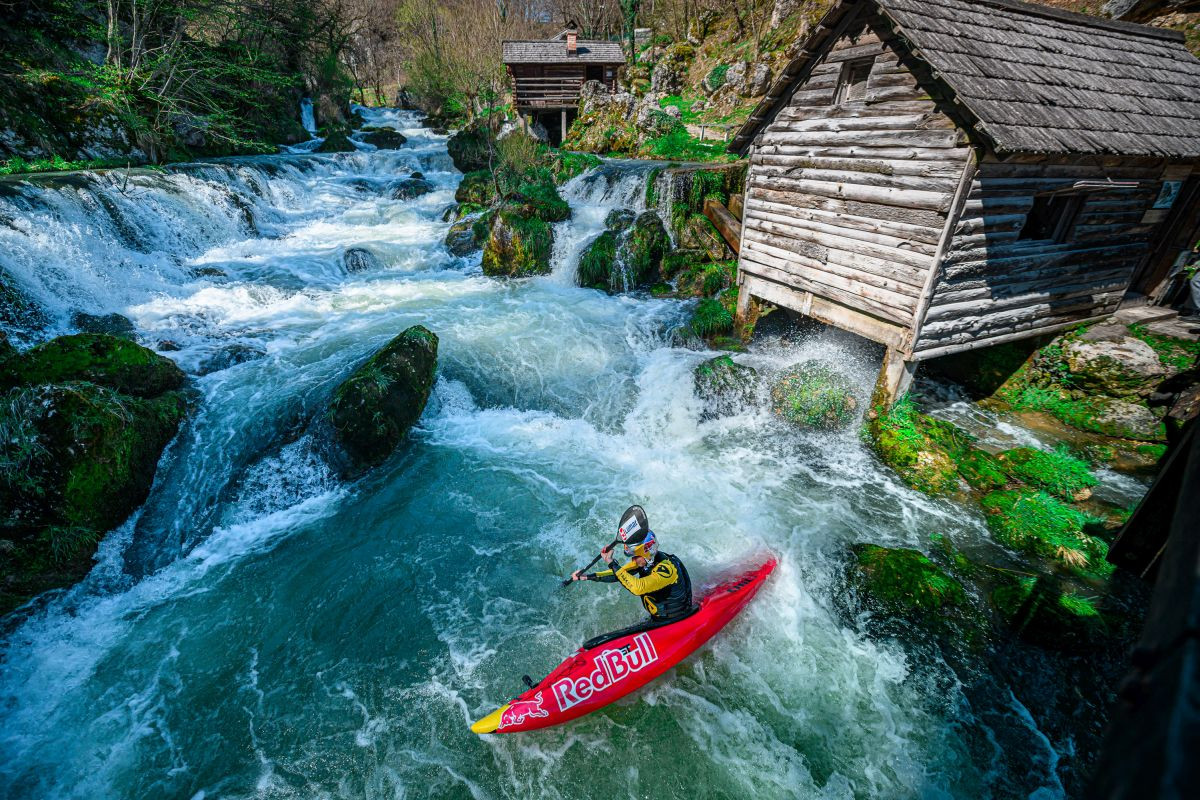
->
[470,558,775,733]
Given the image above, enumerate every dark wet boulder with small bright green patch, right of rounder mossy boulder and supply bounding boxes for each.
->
[989,573,1120,651]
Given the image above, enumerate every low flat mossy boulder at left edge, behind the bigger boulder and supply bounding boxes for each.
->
[0,333,185,397]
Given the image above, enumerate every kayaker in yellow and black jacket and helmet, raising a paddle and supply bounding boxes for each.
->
[571,506,692,625]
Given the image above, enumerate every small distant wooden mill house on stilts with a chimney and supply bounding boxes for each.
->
[502,26,625,144]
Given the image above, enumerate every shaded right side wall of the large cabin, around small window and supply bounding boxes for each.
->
[913,158,1165,359]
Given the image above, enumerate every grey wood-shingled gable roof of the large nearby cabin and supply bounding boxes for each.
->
[730,0,1200,158]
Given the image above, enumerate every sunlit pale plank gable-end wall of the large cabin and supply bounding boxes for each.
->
[739,9,970,339]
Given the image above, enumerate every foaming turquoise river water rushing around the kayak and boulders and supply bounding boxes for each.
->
[0,112,1069,799]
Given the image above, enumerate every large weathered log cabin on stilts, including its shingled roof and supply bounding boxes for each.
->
[730,0,1200,404]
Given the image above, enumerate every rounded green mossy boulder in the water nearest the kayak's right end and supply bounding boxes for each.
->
[846,543,976,630]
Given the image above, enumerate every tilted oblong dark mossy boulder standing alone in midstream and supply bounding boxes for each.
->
[324,325,438,475]
